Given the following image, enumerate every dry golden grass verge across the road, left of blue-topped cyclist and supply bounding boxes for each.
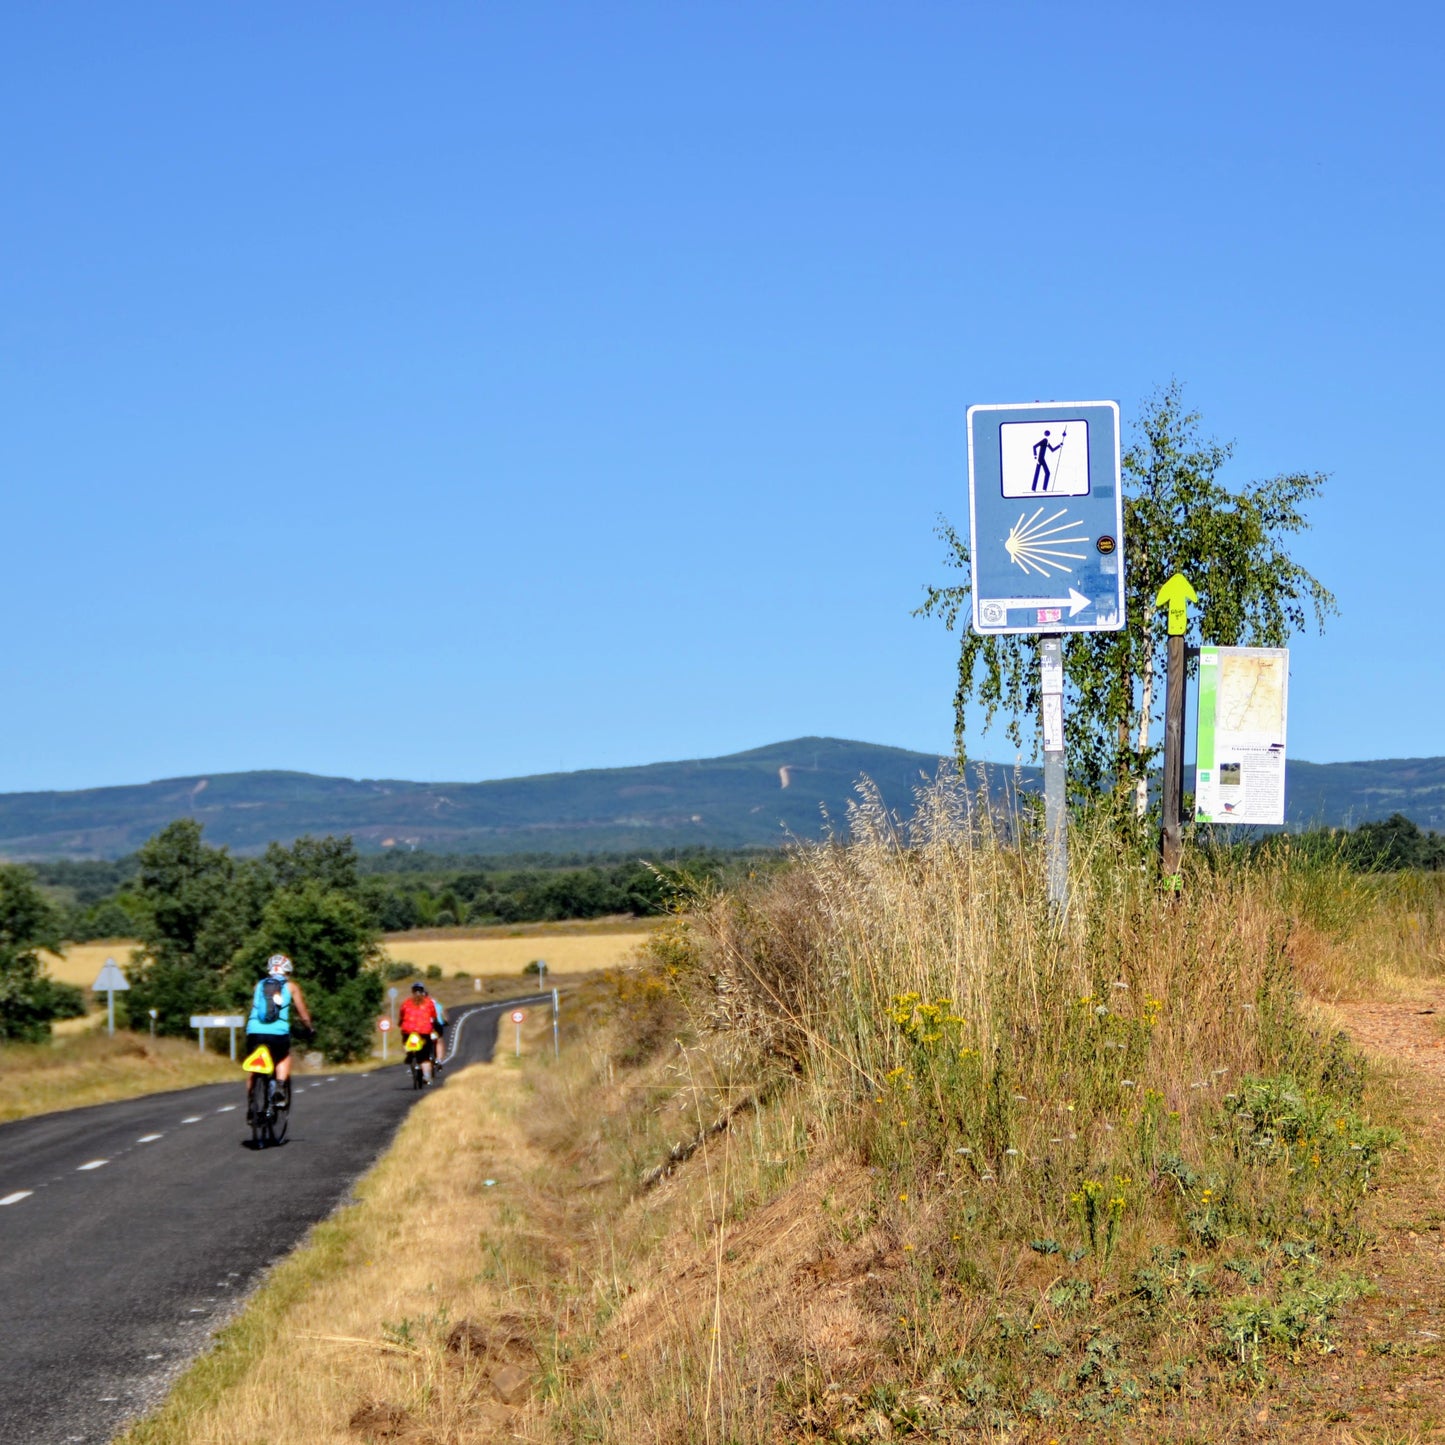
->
[0,1019,240,1121]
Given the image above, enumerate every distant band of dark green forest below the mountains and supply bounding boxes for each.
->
[16,814,1445,944]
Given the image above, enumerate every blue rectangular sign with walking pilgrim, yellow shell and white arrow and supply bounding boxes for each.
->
[968,402,1124,633]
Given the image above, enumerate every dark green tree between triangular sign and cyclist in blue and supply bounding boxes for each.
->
[127,818,249,1035]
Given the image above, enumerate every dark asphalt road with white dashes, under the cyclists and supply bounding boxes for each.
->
[0,998,549,1445]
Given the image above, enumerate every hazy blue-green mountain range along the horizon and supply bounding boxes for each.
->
[0,737,1445,858]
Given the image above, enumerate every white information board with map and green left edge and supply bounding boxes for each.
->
[1194,647,1289,824]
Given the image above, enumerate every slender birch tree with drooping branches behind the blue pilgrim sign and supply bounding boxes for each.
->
[919,381,1337,806]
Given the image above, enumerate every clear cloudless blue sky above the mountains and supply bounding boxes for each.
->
[0,0,1445,790]
